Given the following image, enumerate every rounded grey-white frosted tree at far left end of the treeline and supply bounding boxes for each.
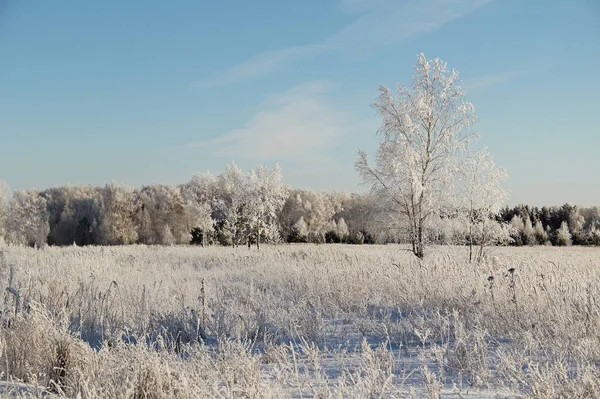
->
[6,189,50,247]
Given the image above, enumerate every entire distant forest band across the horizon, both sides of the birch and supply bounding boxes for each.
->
[0,170,600,247]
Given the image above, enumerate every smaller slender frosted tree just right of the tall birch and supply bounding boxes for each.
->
[458,148,509,261]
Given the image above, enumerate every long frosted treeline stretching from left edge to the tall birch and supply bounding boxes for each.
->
[0,164,384,247]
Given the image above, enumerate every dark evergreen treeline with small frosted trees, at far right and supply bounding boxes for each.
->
[500,204,600,246]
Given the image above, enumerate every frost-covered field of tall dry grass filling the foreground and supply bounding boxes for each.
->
[0,245,600,398]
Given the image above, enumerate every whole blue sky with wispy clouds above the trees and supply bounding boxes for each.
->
[0,0,600,205]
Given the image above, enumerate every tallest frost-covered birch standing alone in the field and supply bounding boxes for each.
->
[356,54,477,258]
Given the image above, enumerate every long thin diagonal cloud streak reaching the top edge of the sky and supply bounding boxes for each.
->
[193,0,491,87]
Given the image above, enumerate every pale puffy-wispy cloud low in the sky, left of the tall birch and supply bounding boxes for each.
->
[190,81,347,161]
